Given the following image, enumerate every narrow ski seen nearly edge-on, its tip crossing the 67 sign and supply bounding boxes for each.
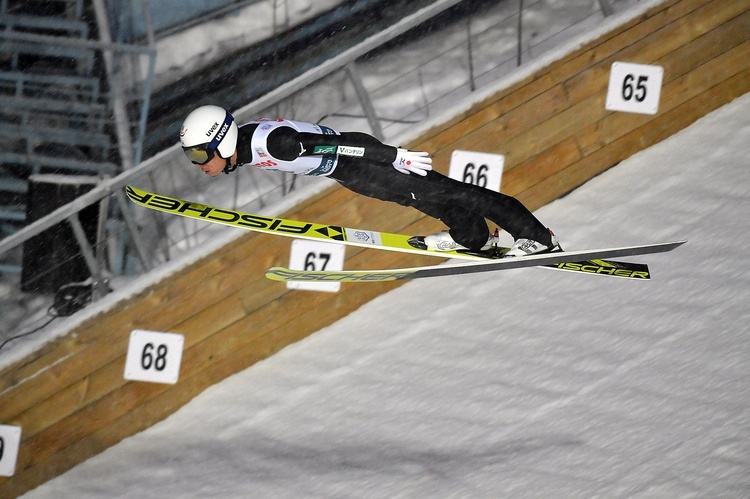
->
[266,241,686,282]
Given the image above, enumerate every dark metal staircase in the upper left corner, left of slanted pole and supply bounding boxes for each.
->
[0,0,106,232]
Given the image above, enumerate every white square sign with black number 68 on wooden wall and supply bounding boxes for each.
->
[125,329,185,384]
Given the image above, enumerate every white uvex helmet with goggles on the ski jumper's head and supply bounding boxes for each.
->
[180,106,238,165]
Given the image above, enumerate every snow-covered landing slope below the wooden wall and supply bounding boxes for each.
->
[23,94,750,498]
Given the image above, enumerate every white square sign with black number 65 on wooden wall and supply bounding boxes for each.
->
[606,62,664,114]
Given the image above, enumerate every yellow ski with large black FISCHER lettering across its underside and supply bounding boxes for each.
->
[125,186,684,279]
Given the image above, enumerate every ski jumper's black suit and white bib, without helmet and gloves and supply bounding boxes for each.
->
[237,120,551,249]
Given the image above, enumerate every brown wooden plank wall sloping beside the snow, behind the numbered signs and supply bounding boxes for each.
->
[0,0,750,497]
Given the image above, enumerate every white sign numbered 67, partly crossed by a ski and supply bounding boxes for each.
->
[286,239,346,293]
